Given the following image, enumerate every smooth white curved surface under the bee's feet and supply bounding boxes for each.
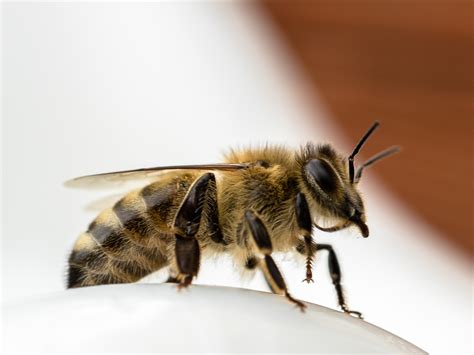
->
[5,284,424,354]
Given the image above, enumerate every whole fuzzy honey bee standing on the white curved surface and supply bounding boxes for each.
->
[66,122,399,317]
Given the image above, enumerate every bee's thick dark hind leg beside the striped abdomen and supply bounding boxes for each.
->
[174,173,215,288]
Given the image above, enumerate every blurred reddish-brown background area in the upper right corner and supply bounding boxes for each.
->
[262,0,474,256]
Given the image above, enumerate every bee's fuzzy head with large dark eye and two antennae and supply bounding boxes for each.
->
[298,122,399,238]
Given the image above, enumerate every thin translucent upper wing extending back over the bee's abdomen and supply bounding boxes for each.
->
[64,164,250,189]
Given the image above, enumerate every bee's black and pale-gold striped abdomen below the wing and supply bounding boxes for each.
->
[67,175,193,288]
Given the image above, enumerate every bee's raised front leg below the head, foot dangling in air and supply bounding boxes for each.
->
[295,192,316,283]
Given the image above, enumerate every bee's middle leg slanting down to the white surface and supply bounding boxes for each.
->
[245,211,306,311]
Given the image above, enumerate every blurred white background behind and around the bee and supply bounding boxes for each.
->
[2,2,472,353]
